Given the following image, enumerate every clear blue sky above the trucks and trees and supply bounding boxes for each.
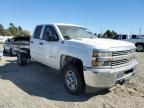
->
[0,0,144,34]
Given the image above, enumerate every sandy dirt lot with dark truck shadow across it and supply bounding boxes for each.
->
[0,44,144,108]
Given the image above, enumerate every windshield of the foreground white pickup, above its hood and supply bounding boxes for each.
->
[58,26,96,40]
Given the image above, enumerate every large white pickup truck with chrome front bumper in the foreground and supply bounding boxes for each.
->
[17,24,138,94]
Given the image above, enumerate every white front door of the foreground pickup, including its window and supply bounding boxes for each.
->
[42,25,60,69]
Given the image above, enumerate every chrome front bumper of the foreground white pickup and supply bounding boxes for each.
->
[84,60,138,93]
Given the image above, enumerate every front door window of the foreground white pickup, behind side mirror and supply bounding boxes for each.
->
[42,25,58,41]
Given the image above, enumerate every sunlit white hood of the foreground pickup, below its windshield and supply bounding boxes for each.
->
[66,38,135,50]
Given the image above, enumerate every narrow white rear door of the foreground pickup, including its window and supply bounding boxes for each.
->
[30,25,43,62]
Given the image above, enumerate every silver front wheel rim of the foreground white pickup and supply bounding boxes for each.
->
[65,71,77,90]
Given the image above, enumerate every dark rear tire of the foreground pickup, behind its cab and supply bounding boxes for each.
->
[17,53,27,66]
